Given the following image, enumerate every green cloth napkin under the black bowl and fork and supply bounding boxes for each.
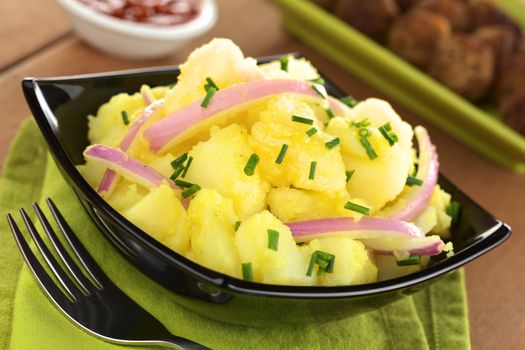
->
[0,120,470,350]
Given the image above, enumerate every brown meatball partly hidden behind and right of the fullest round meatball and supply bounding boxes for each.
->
[474,24,520,70]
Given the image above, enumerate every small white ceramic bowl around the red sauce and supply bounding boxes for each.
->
[58,0,217,60]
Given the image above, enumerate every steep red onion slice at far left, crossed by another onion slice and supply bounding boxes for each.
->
[97,99,164,197]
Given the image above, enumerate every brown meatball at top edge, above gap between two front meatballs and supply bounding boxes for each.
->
[416,0,472,31]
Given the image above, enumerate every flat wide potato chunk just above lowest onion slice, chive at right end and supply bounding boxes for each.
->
[268,187,367,222]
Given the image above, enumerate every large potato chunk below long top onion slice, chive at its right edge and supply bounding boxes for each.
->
[184,124,270,220]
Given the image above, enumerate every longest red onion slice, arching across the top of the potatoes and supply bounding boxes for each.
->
[144,79,342,152]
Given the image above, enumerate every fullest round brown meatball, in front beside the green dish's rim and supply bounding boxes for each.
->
[428,34,494,102]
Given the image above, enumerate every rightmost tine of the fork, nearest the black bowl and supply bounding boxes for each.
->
[46,198,108,289]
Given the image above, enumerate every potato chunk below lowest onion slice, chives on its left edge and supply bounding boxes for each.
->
[308,237,377,286]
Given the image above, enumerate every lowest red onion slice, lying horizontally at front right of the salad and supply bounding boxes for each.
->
[287,217,444,256]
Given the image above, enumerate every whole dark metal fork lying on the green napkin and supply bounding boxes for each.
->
[7,198,209,350]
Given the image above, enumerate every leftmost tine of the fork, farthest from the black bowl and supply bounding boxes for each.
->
[7,214,71,307]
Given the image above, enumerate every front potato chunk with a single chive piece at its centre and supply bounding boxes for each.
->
[235,210,315,285]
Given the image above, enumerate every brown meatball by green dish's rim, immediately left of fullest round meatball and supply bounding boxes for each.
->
[388,10,451,69]
